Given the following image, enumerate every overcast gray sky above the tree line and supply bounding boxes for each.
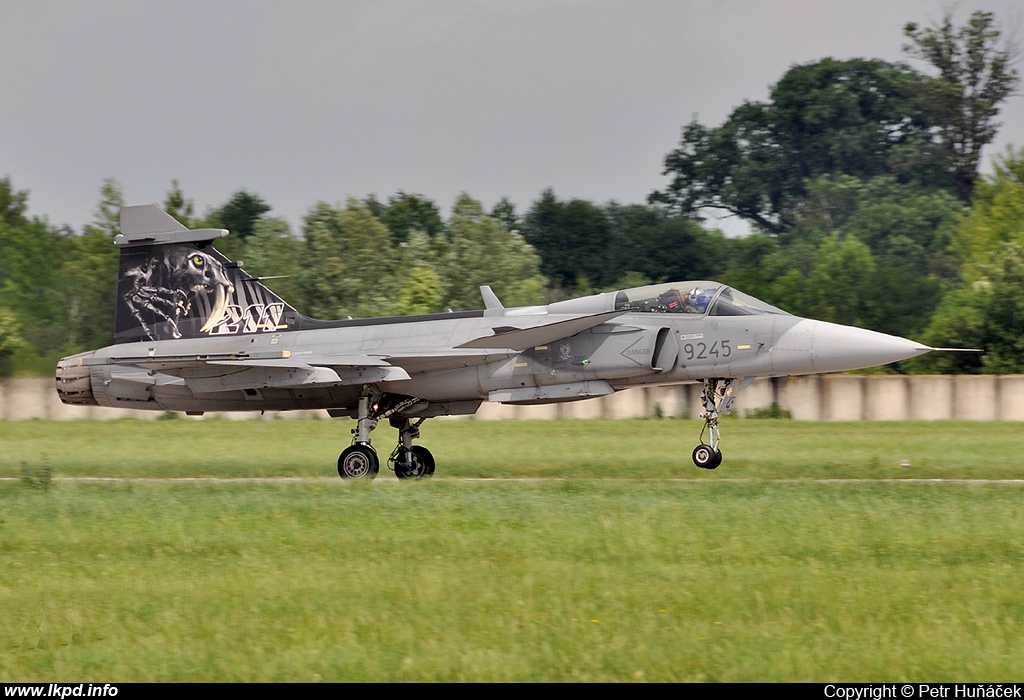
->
[0,0,1024,235]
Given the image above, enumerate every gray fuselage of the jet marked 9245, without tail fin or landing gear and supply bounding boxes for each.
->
[69,282,926,415]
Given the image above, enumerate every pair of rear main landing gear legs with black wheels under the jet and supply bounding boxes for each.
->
[338,394,434,479]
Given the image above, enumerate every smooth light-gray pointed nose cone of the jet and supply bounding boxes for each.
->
[810,321,931,371]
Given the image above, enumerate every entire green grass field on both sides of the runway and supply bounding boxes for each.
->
[0,421,1024,682]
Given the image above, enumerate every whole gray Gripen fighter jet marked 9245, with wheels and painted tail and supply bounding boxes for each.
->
[56,205,933,479]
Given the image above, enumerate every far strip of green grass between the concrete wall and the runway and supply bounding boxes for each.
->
[0,420,1024,480]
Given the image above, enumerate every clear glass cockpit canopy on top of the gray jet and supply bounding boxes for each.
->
[615,280,791,316]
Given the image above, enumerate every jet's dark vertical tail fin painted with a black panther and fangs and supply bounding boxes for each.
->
[114,205,300,343]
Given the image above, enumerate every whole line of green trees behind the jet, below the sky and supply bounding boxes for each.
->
[0,12,1024,375]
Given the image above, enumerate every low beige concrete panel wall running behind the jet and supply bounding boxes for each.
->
[6,375,1024,421]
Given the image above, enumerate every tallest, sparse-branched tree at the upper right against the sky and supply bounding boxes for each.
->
[903,10,1020,203]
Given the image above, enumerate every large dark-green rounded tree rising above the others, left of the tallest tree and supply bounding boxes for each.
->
[651,58,928,234]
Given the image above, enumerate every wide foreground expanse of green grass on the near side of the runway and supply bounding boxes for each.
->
[0,479,1024,682]
